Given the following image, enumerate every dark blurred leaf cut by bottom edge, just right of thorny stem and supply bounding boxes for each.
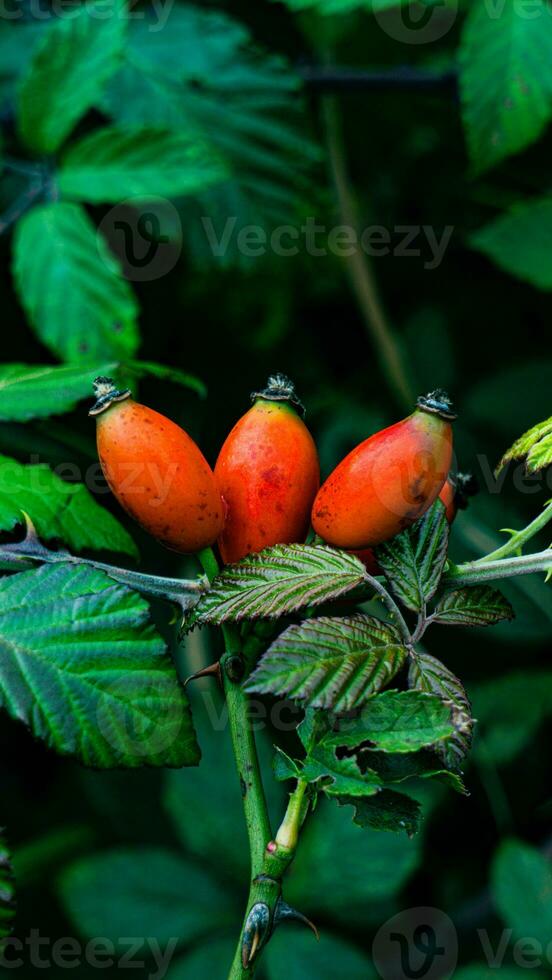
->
[266,929,376,980]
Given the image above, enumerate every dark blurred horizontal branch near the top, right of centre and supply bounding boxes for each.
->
[298,65,458,96]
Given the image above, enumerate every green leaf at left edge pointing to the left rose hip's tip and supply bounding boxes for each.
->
[0,362,118,422]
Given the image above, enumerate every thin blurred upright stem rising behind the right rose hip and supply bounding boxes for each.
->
[322,96,413,407]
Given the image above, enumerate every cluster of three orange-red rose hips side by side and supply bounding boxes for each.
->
[90,375,470,572]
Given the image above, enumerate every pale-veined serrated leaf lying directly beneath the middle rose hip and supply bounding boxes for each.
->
[187,544,364,626]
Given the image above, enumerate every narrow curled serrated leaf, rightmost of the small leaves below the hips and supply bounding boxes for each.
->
[408,653,473,770]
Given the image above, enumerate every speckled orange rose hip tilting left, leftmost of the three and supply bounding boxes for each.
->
[90,378,224,553]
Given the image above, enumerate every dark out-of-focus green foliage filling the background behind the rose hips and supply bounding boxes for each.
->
[0,0,552,980]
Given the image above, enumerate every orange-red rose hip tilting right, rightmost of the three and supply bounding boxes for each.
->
[312,390,456,549]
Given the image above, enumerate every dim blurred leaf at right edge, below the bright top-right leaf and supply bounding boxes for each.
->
[469,196,552,290]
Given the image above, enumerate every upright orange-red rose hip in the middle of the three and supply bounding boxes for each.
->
[215,375,320,564]
